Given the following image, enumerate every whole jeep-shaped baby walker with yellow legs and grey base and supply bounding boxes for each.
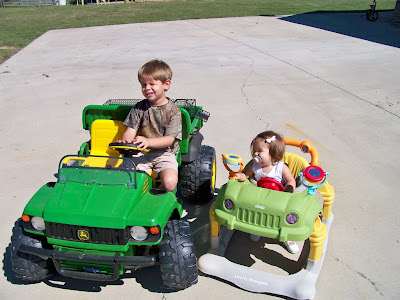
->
[197,138,335,299]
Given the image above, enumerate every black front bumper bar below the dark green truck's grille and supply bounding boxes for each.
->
[18,245,156,281]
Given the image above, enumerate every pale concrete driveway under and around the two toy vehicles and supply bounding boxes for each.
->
[0,12,400,299]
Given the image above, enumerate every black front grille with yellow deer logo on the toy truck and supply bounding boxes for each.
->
[46,222,129,245]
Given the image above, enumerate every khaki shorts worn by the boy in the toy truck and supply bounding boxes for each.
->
[132,152,178,176]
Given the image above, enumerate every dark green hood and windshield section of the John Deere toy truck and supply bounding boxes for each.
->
[24,158,183,253]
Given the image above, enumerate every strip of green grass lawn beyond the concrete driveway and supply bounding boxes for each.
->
[0,0,396,63]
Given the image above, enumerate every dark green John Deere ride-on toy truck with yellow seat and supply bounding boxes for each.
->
[11,99,215,290]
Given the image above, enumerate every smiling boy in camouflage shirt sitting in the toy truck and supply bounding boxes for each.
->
[119,60,182,191]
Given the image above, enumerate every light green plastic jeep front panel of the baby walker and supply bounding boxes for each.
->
[214,180,322,241]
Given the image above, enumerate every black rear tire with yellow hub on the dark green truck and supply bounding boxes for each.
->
[179,145,216,203]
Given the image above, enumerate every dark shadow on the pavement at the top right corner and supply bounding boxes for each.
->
[280,10,400,48]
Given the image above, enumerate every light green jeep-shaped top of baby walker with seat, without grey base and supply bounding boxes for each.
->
[213,138,332,242]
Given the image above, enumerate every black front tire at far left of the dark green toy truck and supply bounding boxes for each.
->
[10,219,54,282]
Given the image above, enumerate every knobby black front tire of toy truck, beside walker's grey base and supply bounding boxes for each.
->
[158,220,198,290]
